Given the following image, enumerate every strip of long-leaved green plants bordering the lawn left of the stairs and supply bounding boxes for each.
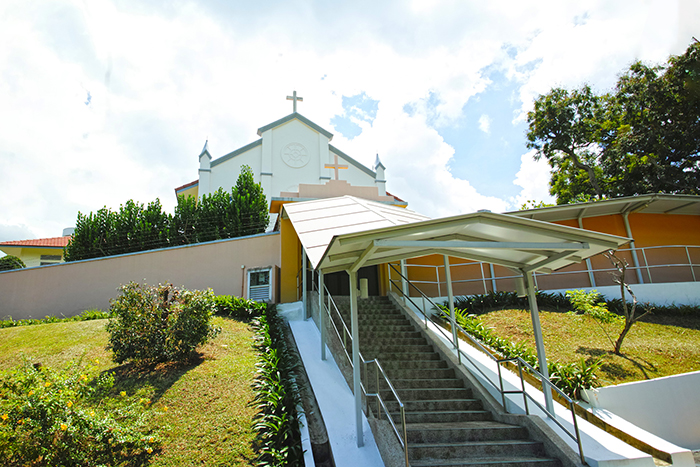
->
[252,308,304,466]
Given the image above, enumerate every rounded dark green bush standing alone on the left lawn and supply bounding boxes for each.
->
[106,282,221,364]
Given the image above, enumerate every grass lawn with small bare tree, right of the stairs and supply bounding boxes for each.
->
[480,310,700,386]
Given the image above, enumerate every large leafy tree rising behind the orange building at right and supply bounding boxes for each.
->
[527,42,700,204]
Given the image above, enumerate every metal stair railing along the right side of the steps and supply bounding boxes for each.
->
[389,263,587,465]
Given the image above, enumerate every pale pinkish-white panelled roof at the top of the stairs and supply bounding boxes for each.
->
[282,196,430,268]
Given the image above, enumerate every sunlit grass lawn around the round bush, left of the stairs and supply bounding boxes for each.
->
[0,317,256,466]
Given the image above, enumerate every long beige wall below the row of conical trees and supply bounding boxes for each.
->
[0,233,280,320]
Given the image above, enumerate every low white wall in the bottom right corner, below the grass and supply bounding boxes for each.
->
[590,371,700,450]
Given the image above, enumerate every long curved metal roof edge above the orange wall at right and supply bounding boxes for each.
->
[507,194,700,222]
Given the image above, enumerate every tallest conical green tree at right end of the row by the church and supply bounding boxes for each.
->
[233,165,270,236]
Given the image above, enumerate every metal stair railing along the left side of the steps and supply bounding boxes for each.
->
[312,281,409,467]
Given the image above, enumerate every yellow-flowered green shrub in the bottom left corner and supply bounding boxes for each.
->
[0,362,161,466]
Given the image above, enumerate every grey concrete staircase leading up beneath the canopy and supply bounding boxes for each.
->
[336,297,561,467]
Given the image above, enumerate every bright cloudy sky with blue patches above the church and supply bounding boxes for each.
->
[0,0,700,245]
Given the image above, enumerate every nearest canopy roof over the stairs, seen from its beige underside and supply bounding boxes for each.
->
[314,208,630,273]
